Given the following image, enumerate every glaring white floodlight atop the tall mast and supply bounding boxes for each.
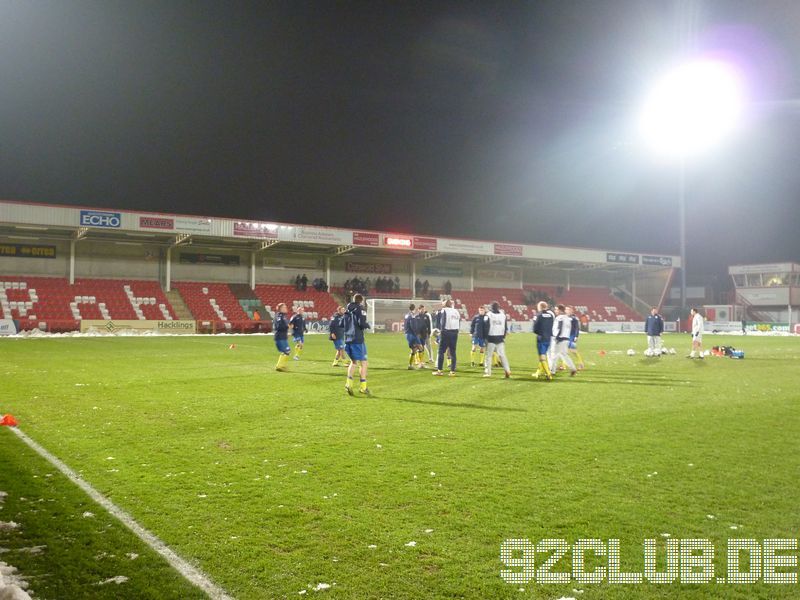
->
[640,61,744,157]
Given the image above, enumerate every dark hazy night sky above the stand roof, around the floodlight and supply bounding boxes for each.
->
[0,0,800,283]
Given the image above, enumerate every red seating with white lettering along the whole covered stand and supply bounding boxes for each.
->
[0,276,643,331]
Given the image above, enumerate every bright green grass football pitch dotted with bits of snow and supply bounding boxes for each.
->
[0,334,800,600]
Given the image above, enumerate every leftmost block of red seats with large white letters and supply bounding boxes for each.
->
[0,276,175,331]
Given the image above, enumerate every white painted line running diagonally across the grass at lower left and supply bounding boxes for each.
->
[9,427,232,600]
